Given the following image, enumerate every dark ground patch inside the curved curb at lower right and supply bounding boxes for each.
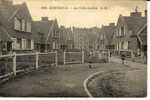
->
[88,70,147,97]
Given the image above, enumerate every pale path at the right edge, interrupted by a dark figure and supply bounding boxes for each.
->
[110,57,147,69]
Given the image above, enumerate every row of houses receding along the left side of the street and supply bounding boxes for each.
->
[0,0,73,54]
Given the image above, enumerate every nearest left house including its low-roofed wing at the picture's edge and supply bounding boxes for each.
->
[0,0,34,53]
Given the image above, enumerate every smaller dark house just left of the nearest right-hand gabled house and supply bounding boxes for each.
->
[98,23,116,50]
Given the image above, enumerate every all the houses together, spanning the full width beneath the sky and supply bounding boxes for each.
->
[0,0,147,55]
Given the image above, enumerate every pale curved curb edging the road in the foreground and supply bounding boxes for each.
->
[83,71,104,97]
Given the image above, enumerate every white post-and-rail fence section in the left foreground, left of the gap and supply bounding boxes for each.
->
[0,52,58,79]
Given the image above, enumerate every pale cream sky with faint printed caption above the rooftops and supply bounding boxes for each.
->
[13,0,147,28]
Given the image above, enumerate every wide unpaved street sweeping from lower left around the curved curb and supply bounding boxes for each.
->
[0,62,138,97]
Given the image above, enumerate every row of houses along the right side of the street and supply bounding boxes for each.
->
[98,9,147,56]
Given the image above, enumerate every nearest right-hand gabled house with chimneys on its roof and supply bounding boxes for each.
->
[114,9,147,56]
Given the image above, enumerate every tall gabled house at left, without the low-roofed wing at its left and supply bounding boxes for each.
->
[0,0,34,53]
